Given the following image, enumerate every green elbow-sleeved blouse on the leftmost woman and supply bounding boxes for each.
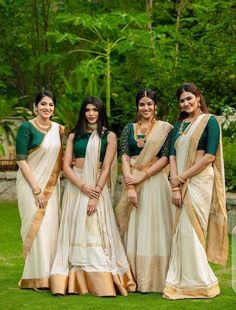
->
[16,122,45,160]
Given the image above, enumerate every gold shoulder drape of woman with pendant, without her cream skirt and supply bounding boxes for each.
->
[115,121,173,240]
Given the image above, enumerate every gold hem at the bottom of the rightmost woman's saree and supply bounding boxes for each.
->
[163,282,220,299]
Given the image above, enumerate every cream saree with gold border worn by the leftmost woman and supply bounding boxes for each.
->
[16,122,63,288]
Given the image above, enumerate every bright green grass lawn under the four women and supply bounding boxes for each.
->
[0,203,236,310]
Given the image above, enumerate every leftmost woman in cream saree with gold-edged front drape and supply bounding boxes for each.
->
[16,91,63,290]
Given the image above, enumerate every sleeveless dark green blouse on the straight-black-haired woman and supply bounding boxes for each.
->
[73,130,109,162]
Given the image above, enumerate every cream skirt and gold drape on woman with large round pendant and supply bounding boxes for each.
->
[116,121,174,292]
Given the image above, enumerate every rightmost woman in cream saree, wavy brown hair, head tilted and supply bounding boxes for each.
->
[164,83,228,299]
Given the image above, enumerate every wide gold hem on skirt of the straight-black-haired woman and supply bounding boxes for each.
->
[50,269,136,297]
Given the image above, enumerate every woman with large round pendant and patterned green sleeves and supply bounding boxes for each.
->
[116,90,173,292]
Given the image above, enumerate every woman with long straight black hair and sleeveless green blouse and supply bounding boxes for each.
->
[50,96,136,296]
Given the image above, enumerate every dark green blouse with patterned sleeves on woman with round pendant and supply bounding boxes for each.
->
[120,123,171,158]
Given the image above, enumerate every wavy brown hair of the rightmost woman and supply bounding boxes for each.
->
[176,83,209,121]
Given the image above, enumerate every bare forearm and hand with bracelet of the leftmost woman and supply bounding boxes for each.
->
[17,160,46,209]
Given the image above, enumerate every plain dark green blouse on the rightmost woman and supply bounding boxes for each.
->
[170,115,220,156]
